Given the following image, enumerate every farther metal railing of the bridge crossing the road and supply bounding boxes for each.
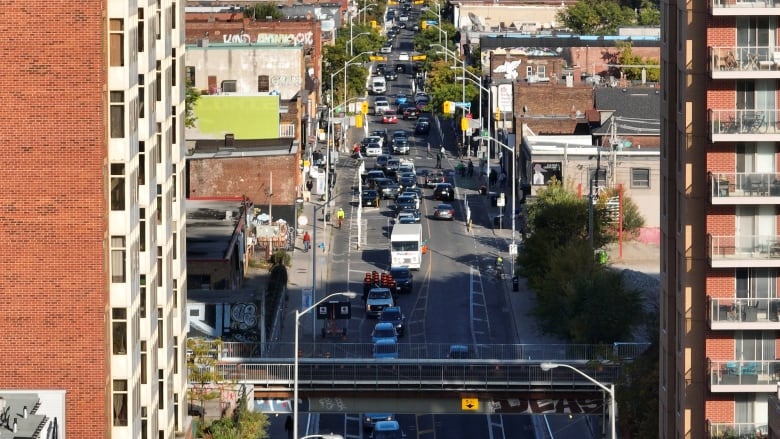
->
[220,340,649,362]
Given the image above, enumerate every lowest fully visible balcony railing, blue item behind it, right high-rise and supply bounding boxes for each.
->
[709,360,780,393]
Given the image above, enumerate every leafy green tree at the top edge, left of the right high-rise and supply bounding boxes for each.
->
[558,0,636,35]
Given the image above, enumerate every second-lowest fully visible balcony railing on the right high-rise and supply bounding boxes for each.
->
[710,297,780,330]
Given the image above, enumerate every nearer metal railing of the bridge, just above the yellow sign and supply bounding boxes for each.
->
[213,359,622,391]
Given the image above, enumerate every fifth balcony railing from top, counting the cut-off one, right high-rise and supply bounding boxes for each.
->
[708,235,780,268]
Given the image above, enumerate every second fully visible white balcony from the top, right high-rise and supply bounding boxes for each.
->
[709,108,780,142]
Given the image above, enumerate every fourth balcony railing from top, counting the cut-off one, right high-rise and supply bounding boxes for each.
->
[710,172,780,204]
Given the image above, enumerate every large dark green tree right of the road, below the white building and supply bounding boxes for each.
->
[518,181,641,343]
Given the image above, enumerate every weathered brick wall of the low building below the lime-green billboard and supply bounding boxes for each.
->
[187,154,301,206]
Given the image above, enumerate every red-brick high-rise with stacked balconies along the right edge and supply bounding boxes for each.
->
[659,0,780,438]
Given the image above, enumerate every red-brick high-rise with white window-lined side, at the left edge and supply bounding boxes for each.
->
[0,0,190,439]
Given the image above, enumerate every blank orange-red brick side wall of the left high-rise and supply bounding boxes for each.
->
[0,1,109,438]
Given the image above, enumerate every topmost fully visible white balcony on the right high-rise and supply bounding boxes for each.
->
[710,46,780,79]
